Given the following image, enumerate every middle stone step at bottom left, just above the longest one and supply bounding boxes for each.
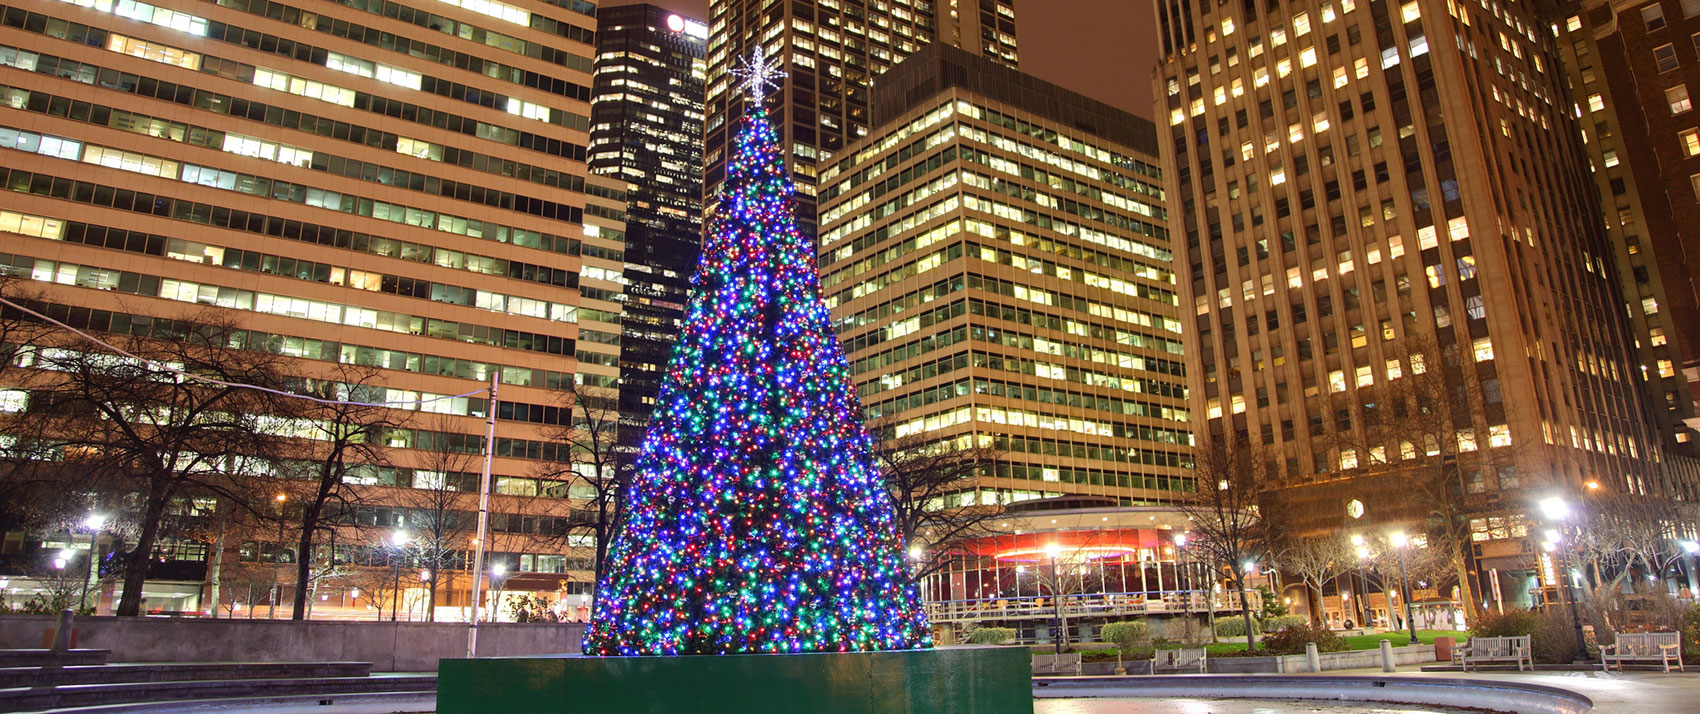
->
[0,661,372,689]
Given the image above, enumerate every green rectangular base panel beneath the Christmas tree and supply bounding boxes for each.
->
[437,648,1034,714]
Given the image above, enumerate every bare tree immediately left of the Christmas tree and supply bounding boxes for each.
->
[536,383,632,605]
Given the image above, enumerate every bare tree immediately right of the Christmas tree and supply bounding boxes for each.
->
[869,423,1003,581]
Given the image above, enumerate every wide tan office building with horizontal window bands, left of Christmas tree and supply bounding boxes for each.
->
[0,0,626,617]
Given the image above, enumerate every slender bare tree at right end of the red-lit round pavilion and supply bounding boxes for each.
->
[1176,442,1273,649]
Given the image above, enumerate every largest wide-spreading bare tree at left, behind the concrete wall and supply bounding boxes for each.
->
[14,315,282,617]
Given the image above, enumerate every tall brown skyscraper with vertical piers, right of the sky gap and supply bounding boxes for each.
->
[1154,0,1693,597]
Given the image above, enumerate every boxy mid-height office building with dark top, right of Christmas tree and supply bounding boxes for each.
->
[819,43,1192,507]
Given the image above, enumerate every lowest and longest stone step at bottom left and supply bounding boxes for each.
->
[0,675,437,712]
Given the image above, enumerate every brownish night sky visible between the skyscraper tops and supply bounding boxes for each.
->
[600,0,1158,119]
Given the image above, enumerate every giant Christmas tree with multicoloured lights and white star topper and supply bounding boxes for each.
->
[585,48,932,655]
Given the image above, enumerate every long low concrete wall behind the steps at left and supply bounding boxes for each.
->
[0,615,585,672]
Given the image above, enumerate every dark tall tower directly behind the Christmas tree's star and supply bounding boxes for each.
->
[704,0,1017,235]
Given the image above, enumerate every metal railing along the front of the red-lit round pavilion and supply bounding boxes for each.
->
[927,590,1261,624]
